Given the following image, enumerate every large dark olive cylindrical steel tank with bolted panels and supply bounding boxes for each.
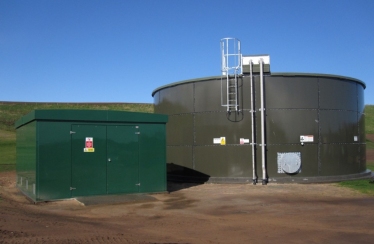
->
[152,73,370,182]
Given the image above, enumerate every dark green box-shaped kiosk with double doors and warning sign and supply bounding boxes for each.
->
[15,110,168,202]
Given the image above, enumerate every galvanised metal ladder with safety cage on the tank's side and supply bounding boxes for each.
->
[221,37,243,113]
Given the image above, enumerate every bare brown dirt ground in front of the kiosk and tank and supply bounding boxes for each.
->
[0,172,374,243]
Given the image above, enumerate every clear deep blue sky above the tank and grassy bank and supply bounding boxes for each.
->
[0,0,374,104]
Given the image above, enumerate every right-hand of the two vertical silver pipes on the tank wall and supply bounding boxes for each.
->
[260,58,267,185]
